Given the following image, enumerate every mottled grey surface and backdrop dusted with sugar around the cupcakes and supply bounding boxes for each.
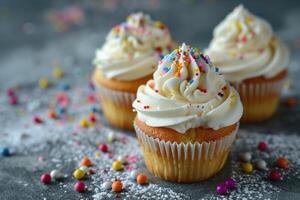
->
[0,0,300,199]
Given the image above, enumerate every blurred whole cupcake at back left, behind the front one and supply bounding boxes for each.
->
[93,13,173,129]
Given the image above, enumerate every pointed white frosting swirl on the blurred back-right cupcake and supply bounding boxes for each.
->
[205,5,289,82]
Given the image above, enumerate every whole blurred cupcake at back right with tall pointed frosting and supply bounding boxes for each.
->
[205,5,290,122]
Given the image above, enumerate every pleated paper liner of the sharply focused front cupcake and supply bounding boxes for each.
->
[134,122,238,182]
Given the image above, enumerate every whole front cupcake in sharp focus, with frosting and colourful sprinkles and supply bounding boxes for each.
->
[133,44,243,183]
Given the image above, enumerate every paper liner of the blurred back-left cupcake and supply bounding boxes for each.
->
[97,86,136,130]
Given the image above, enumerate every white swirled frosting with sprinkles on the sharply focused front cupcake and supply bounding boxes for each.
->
[133,44,243,133]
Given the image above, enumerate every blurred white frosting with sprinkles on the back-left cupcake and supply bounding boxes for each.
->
[93,13,172,81]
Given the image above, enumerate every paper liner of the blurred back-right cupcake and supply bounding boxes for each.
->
[233,79,285,122]
